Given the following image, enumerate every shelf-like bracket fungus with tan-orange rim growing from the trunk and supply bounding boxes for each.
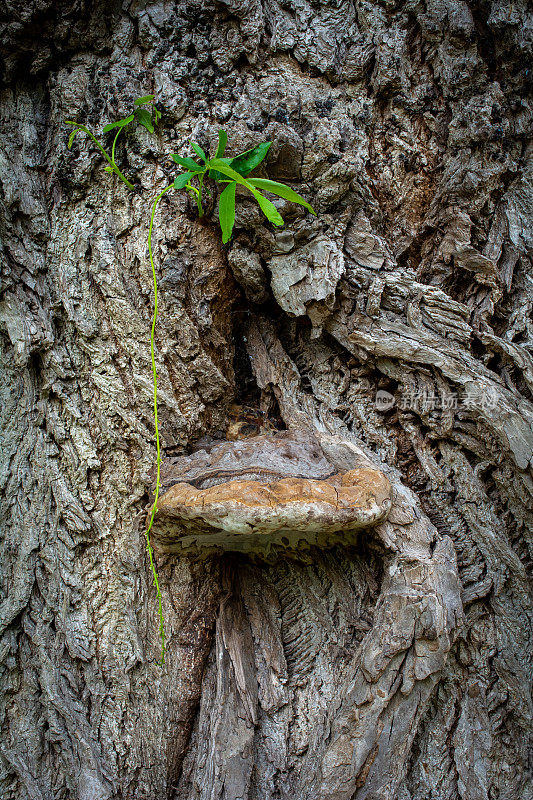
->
[148,431,392,558]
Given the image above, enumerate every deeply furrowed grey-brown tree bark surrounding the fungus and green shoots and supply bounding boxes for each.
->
[0,0,533,800]
